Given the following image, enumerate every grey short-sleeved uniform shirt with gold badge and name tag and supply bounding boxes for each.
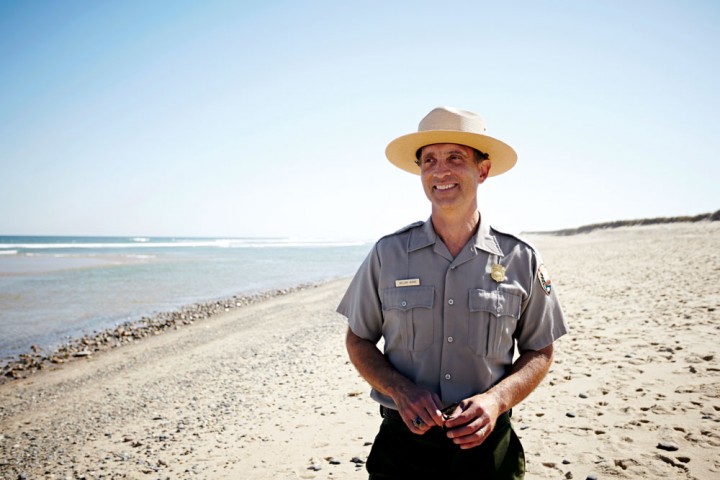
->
[337,220,568,408]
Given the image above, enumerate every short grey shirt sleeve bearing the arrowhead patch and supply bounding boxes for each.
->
[516,251,569,352]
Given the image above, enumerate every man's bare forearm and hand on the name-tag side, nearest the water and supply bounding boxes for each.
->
[345,328,444,433]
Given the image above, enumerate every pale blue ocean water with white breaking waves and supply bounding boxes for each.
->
[0,236,371,362]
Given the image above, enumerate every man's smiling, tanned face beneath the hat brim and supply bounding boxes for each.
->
[420,143,490,213]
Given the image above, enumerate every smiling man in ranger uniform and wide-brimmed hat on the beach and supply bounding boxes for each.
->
[338,107,567,479]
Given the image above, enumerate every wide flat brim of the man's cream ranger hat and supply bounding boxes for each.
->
[385,130,517,177]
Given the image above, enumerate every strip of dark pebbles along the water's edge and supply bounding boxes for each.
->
[0,279,339,385]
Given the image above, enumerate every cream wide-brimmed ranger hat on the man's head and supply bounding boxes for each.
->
[385,107,517,177]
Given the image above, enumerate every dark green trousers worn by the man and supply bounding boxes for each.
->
[366,407,525,480]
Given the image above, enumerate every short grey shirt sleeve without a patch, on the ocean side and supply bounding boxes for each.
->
[337,244,383,343]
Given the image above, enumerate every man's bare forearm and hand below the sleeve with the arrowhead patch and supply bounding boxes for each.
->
[445,344,553,449]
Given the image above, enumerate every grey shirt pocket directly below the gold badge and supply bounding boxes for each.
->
[468,289,522,358]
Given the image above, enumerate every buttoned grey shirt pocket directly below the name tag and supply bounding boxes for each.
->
[382,286,435,351]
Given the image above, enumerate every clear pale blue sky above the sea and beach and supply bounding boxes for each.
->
[0,0,720,240]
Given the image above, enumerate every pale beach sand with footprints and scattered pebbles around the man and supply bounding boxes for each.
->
[0,222,720,480]
